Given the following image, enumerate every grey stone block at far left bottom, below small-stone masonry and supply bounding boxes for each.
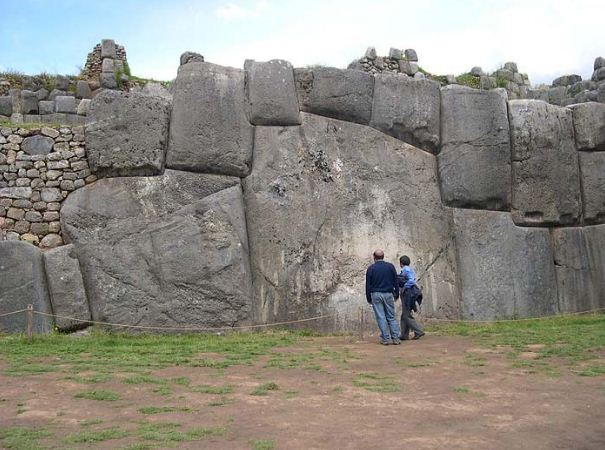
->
[0,241,53,333]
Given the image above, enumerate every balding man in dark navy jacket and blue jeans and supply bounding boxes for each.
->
[366,250,401,345]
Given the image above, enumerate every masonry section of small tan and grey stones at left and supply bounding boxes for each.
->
[0,126,97,248]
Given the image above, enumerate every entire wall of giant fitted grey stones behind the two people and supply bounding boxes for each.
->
[0,41,605,332]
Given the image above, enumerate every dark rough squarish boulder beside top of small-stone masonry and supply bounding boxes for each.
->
[86,90,170,176]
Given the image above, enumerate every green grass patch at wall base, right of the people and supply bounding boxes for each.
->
[431,314,605,376]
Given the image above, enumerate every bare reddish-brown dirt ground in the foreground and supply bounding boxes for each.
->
[0,335,605,450]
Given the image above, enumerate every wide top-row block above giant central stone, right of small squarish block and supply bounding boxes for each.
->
[294,67,374,125]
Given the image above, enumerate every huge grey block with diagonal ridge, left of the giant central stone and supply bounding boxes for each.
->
[61,170,252,327]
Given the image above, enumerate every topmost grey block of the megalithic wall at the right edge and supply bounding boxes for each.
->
[571,102,605,150]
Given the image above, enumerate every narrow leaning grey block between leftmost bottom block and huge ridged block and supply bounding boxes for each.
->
[44,244,90,331]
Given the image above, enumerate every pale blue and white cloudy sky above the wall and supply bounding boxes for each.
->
[0,0,605,84]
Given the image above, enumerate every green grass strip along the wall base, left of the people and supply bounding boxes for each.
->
[0,331,301,382]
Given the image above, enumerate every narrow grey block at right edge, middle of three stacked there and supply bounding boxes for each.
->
[579,152,605,223]
